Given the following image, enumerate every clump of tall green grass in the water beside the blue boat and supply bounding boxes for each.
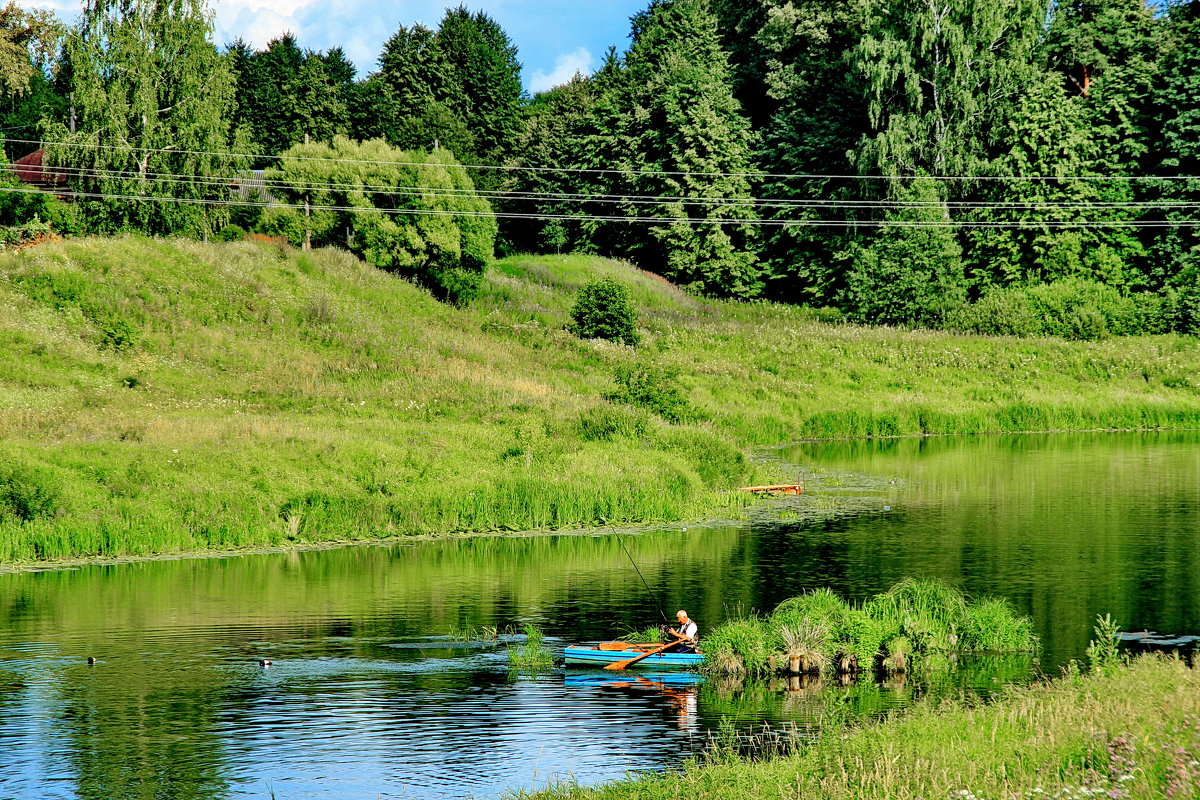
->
[703,578,1037,675]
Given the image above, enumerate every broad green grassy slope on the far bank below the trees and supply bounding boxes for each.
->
[0,237,1200,563]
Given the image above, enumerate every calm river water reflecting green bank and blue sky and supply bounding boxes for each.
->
[0,433,1200,800]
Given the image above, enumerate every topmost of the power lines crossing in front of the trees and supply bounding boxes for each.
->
[7,139,1200,182]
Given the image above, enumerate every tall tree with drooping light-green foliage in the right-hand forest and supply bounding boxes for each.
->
[852,0,1046,321]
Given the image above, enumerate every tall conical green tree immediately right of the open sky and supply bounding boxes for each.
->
[596,0,762,297]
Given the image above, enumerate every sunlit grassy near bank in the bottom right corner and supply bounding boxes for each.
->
[523,658,1200,800]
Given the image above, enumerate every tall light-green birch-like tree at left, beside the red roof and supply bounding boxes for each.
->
[43,0,244,235]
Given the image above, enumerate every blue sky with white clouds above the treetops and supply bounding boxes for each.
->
[20,0,649,91]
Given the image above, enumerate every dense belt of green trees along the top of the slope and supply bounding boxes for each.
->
[0,0,1200,338]
